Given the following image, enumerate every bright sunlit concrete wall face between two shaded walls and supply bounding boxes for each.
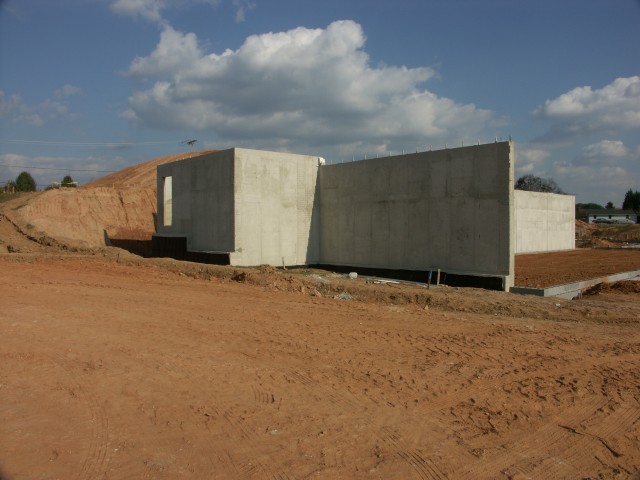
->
[231,148,319,265]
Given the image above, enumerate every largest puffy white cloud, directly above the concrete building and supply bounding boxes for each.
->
[124,21,497,156]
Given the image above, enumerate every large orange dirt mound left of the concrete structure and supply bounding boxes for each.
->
[0,152,214,253]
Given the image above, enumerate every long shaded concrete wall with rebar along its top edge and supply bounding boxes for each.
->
[319,142,515,288]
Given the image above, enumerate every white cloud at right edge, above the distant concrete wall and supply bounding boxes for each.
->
[534,76,640,139]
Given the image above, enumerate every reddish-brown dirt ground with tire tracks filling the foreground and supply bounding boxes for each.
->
[0,251,640,480]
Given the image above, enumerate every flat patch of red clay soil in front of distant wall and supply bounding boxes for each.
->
[515,248,640,288]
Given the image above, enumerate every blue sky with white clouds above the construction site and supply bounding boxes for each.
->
[0,0,640,207]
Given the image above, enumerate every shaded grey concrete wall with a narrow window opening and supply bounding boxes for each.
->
[157,150,235,252]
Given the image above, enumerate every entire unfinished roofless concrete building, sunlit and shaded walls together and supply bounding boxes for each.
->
[154,142,574,289]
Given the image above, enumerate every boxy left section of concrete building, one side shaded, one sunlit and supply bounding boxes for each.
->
[153,148,321,266]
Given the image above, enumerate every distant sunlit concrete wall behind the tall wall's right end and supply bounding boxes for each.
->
[514,190,576,253]
